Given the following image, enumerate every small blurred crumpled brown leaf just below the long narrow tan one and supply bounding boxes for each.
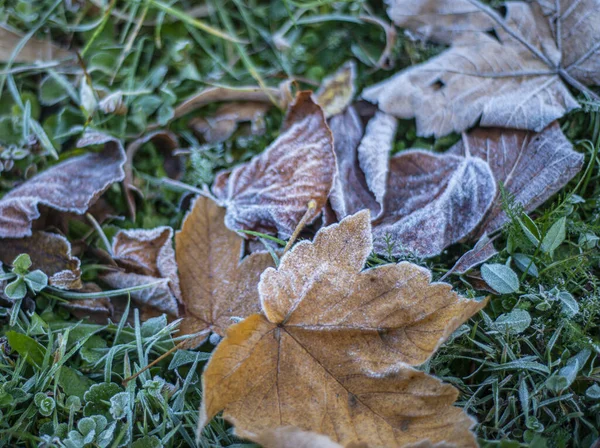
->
[190,102,271,143]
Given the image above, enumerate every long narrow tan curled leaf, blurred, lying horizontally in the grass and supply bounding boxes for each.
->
[173,82,291,119]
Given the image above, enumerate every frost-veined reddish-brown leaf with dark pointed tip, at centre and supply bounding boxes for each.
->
[213,92,335,238]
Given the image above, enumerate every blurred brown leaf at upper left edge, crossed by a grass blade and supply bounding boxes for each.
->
[0,25,75,63]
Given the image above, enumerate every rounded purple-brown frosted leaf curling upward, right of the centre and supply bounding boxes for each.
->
[373,150,496,257]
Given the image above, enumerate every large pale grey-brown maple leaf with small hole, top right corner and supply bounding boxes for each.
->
[363,0,600,136]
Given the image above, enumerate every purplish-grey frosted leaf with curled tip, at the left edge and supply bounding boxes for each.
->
[0,133,125,238]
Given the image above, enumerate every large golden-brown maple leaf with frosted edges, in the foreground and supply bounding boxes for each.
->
[200,211,484,447]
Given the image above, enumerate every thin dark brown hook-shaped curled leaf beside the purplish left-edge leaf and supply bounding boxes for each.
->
[123,130,183,221]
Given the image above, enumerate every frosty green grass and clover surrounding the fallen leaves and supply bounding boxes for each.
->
[0,0,600,448]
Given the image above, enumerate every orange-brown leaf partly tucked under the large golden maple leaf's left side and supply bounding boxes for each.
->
[175,196,274,345]
